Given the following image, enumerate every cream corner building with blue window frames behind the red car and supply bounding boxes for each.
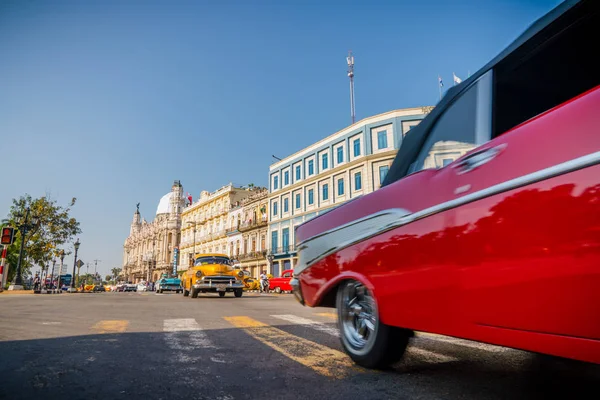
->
[267,107,432,276]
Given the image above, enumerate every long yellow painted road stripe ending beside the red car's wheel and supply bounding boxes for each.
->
[225,317,358,379]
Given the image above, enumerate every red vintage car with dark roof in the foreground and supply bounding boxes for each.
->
[292,1,600,368]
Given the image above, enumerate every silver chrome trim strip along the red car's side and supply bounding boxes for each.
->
[294,151,600,276]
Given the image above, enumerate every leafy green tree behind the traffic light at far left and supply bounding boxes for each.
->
[3,194,81,282]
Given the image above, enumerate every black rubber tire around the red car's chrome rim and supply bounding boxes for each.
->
[336,281,413,369]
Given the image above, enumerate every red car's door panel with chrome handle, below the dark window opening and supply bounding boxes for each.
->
[449,82,600,339]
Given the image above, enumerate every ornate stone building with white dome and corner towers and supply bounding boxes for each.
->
[122,181,185,283]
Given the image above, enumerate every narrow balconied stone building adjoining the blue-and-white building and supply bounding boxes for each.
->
[237,188,269,278]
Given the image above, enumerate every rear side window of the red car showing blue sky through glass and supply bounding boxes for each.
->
[409,72,491,173]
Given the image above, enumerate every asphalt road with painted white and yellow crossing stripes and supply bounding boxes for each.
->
[0,293,600,400]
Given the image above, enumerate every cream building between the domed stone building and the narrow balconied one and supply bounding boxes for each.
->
[179,183,250,271]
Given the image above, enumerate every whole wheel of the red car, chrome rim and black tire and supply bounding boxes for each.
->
[337,280,412,368]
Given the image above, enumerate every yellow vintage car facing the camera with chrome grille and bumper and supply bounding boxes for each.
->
[181,253,244,298]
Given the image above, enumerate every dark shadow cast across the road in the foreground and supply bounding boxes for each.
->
[0,328,600,400]
